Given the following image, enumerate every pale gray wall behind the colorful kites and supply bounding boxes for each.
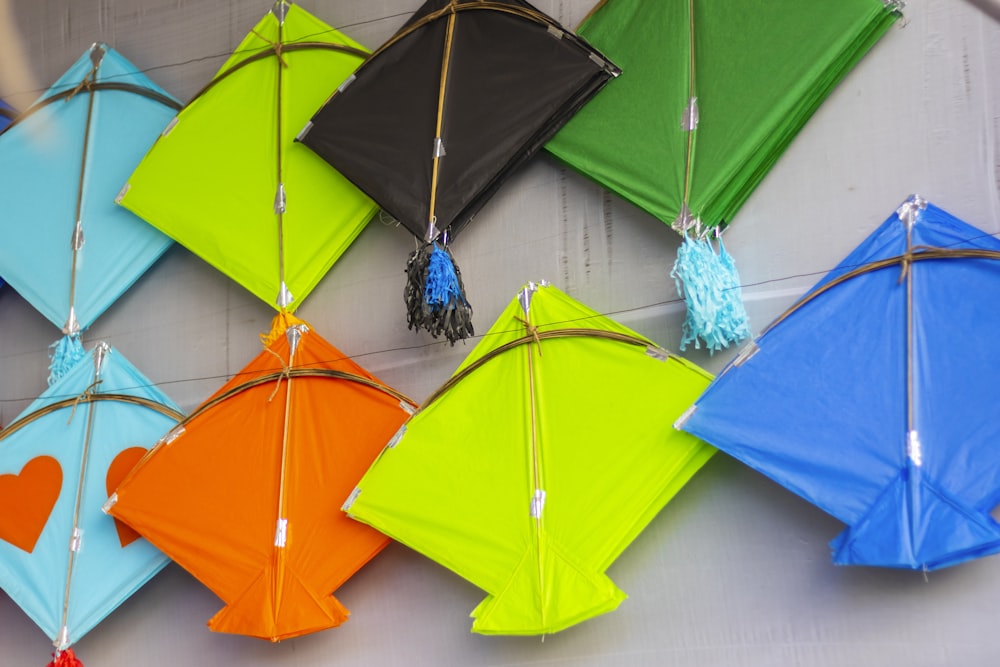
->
[0,0,1000,667]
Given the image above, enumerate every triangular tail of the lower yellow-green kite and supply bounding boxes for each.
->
[472,537,627,635]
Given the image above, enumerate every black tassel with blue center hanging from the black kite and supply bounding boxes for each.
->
[404,242,475,345]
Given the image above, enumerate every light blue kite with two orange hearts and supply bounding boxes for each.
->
[0,343,183,666]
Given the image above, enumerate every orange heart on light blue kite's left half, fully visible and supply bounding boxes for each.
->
[0,456,62,554]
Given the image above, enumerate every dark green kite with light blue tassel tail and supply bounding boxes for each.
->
[546,0,903,352]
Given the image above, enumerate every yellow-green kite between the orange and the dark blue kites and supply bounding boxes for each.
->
[344,283,715,635]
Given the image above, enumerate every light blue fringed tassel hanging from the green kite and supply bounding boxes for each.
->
[670,235,750,352]
